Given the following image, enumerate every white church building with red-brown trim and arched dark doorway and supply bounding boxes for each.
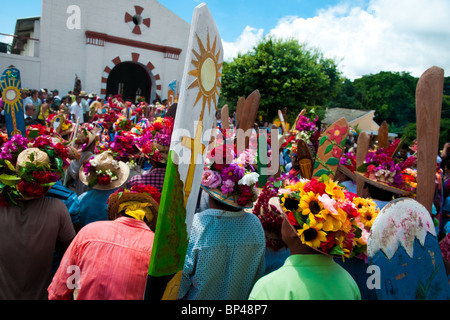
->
[0,0,190,102]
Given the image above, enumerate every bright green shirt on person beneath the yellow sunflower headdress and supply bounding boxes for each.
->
[249,254,361,300]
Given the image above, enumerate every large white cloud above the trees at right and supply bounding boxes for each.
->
[224,0,450,79]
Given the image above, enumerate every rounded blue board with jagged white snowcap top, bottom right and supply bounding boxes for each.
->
[367,198,450,300]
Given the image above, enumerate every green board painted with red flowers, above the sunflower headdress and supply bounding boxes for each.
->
[312,118,348,179]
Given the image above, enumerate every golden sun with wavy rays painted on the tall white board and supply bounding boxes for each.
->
[188,33,223,119]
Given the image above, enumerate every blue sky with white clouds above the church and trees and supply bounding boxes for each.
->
[0,0,450,79]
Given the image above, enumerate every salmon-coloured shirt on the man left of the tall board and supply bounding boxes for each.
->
[48,217,154,300]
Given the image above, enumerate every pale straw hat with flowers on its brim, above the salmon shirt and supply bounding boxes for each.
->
[79,151,130,190]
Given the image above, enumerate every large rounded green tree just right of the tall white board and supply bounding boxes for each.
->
[219,37,341,123]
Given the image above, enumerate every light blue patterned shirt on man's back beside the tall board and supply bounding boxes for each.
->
[179,209,265,300]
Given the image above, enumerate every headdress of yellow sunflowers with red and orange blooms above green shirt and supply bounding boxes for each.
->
[273,175,379,258]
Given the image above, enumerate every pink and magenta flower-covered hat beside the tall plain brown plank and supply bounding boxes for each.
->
[356,139,416,195]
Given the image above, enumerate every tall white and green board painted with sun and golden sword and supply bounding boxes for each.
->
[144,3,223,299]
